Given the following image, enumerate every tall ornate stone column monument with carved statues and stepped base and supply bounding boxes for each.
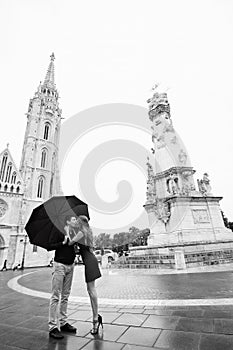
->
[130,90,233,268]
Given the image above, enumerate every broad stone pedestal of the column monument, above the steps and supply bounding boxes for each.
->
[145,196,233,247]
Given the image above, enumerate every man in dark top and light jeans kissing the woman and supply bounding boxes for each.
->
[48,215,77,339]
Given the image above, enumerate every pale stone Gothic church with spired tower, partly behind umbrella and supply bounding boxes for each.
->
[0,54,62,268]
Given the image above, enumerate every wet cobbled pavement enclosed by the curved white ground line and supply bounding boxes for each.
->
[14,265,233,300]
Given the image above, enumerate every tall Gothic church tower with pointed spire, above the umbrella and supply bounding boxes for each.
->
[19,53,62,201]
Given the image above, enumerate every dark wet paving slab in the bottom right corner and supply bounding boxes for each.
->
[198,334,233,350]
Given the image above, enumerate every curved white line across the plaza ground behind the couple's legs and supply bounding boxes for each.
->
[7,272,233,306]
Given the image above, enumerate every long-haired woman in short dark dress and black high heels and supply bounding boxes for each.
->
[69,215,103,334]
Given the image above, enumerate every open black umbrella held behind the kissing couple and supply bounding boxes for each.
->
[25,196,89,249]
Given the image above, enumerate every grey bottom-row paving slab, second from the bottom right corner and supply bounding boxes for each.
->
[155,330,200,350]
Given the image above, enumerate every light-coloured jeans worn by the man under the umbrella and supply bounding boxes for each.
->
[49,261,74,331]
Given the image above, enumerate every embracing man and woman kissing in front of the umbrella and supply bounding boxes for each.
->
[49,215,103,339]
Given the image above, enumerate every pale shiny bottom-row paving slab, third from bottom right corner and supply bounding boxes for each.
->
[117,327,161,346]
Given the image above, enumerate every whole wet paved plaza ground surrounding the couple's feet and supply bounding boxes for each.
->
[0,266,233,350]
